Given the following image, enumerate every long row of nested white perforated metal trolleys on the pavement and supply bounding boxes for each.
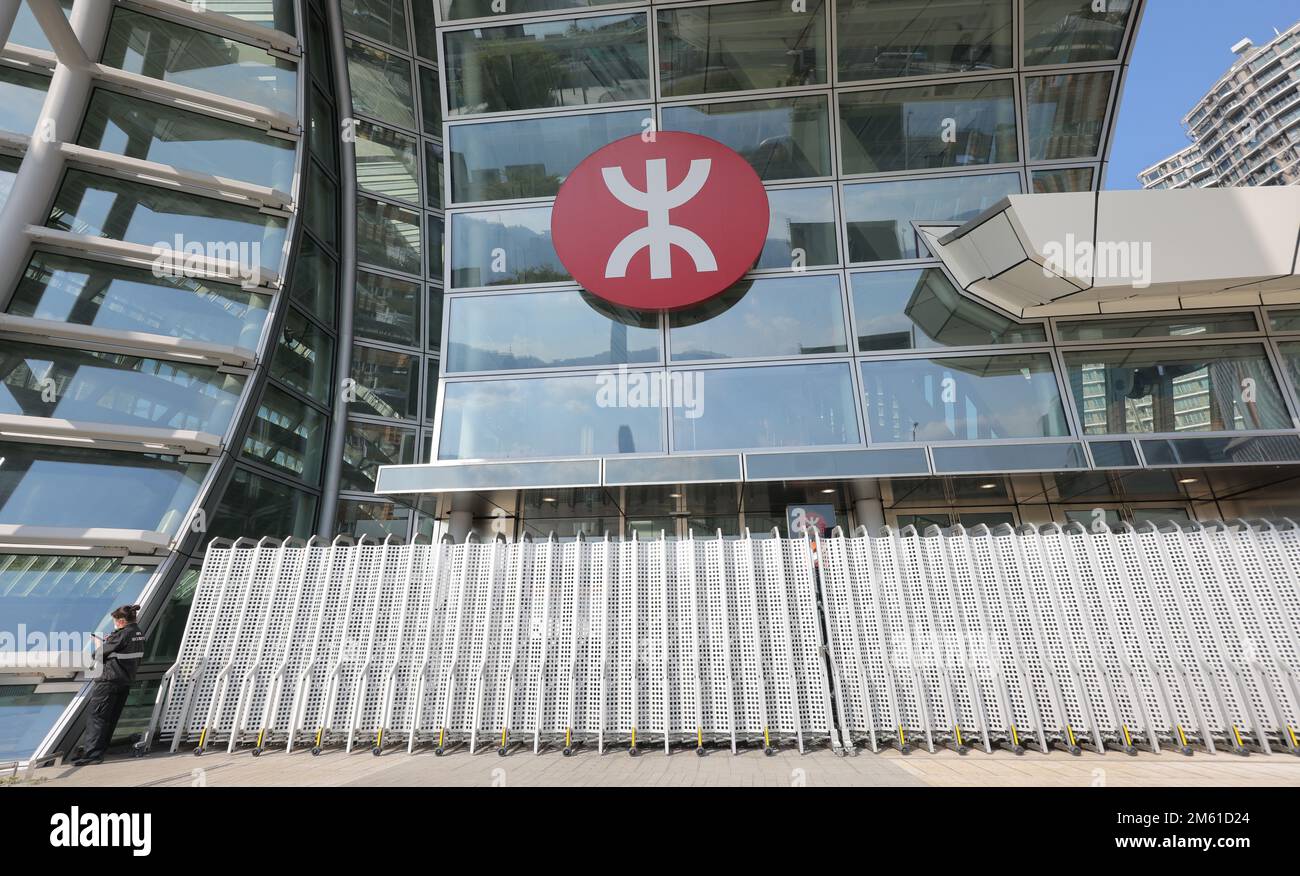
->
[140,521,1300,754]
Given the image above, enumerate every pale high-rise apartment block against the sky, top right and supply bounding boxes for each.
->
[1138,22,1300,188]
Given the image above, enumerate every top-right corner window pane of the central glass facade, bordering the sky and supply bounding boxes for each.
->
[1024,0,1132,66]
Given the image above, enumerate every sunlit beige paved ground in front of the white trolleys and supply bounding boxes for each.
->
[10,749,1300,788]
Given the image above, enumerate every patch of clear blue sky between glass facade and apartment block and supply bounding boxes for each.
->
[1106,0,1300,188]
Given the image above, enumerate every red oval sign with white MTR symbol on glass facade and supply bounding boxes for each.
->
[551,131,768,311]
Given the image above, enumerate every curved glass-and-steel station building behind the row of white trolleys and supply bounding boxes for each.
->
[0,0,1300,762]
